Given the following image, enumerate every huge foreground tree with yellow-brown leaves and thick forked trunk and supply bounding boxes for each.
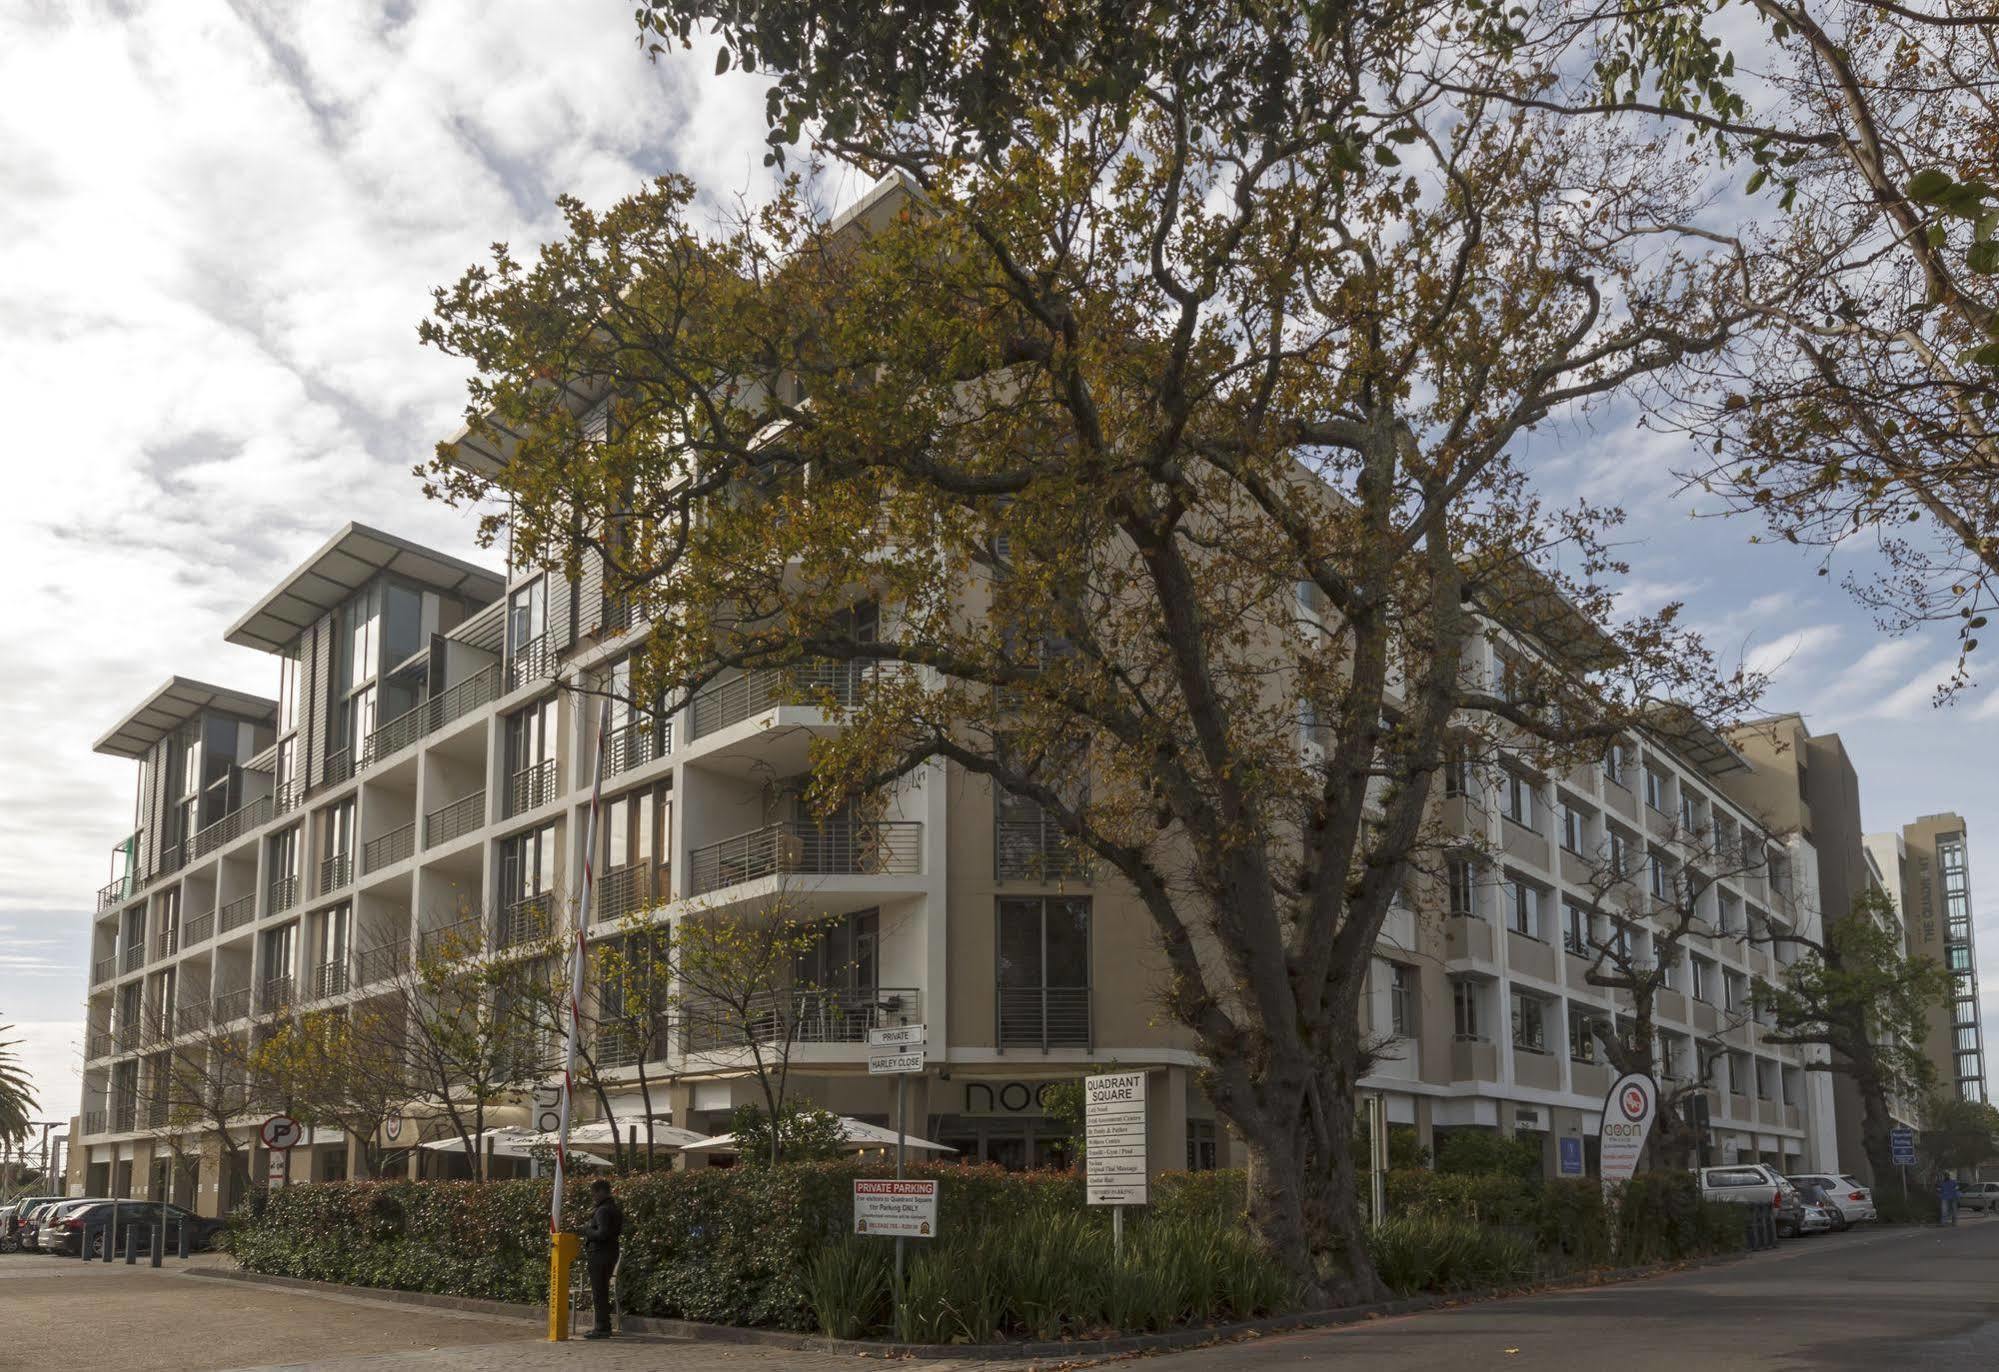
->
[422,0,1755,1298]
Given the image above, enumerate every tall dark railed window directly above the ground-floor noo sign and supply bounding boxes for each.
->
[998,896,1089,1048]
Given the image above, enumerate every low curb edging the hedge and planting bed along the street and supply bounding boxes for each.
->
[178,1252,1755,1362]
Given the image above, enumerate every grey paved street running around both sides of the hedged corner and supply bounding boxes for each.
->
[0,1216,1999,1372]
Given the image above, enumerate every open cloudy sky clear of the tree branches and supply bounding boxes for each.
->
[0,0,1999,1152]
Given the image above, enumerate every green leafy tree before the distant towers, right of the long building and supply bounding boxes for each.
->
[1751,890,1951,1178]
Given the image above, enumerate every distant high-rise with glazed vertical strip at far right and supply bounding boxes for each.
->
[1865,812,1987,1100]
